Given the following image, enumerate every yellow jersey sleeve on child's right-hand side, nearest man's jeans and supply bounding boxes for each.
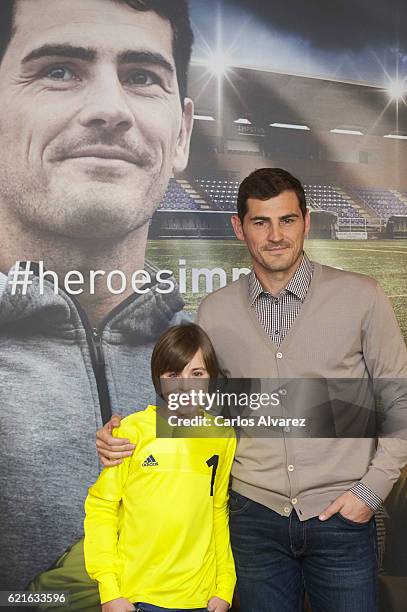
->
[213,430,236,605]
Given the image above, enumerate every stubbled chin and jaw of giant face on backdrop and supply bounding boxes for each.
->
[0,160,168,240]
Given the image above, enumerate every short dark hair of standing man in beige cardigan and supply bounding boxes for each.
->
[237,168,307,223]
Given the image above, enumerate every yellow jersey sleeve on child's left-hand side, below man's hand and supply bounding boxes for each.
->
[84,420,138,604]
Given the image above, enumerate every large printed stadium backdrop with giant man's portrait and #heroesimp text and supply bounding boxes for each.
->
[0,0,407,612]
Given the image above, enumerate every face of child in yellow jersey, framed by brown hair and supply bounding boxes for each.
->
[160,349,209,416]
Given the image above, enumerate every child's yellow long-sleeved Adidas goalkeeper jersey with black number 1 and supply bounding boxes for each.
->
[84,406,236,609]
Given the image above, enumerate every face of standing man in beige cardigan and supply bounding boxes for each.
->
[232,191,309,272]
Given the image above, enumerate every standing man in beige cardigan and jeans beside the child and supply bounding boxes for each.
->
[98,168,407,612]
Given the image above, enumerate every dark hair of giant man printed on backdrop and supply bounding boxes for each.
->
[0,0,194,104]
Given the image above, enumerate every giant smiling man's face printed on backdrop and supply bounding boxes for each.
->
[0,0,193,239]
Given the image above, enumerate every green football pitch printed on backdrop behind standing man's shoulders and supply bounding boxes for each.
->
[147,239,407,341]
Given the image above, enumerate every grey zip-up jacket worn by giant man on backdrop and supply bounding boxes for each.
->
[0,267,185,590]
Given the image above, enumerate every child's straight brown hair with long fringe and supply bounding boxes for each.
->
[151,323,223,395]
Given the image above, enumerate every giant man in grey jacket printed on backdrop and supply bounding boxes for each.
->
[0,0,193,589]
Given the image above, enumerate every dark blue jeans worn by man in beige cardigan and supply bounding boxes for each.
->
[229,491,378,612]
